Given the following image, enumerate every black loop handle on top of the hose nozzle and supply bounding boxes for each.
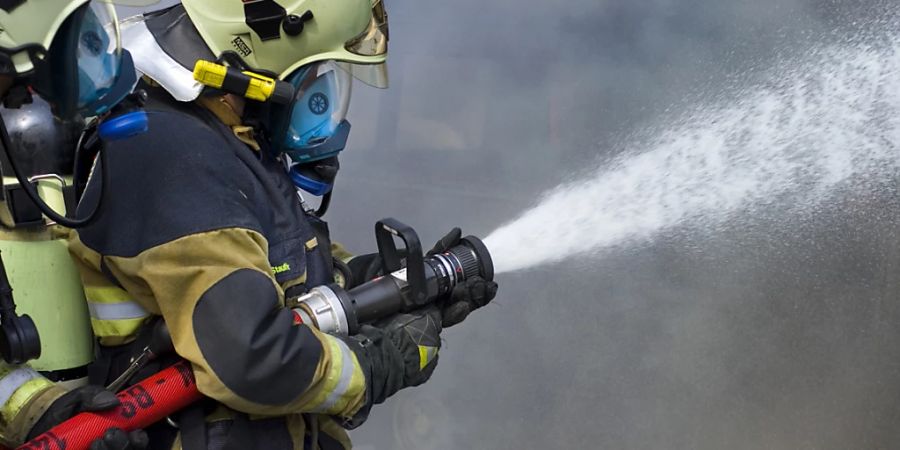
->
[375,218,428,306]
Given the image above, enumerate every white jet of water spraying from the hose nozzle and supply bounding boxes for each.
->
[485,29,900,272]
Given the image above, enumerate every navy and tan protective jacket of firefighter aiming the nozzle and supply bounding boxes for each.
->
[70,91,365,450]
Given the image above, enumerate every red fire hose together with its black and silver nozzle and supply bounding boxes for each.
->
[12,219,494,450]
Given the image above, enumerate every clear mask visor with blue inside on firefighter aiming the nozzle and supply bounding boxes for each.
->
[281,61,351,162]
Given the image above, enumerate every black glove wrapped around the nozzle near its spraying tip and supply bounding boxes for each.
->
[427,228,497,328]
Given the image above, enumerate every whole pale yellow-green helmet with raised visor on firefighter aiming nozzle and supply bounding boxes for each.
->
[182,0,388,86]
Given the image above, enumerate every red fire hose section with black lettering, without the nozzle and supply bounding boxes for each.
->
[17,361,203,450]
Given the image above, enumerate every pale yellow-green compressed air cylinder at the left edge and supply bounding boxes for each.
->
[0,181,93,384]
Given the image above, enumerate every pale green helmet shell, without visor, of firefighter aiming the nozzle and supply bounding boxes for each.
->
[182,0,387,79]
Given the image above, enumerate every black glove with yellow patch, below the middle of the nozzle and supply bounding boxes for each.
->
[344,307,442,428]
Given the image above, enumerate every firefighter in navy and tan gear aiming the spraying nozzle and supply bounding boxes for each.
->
[70,0,496,450]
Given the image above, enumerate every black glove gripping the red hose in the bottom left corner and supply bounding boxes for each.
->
[27,386,148,450]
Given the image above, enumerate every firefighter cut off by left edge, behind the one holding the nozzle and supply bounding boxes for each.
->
[0,0,147,449]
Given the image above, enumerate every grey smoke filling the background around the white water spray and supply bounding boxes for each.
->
[121,0,900,450]
